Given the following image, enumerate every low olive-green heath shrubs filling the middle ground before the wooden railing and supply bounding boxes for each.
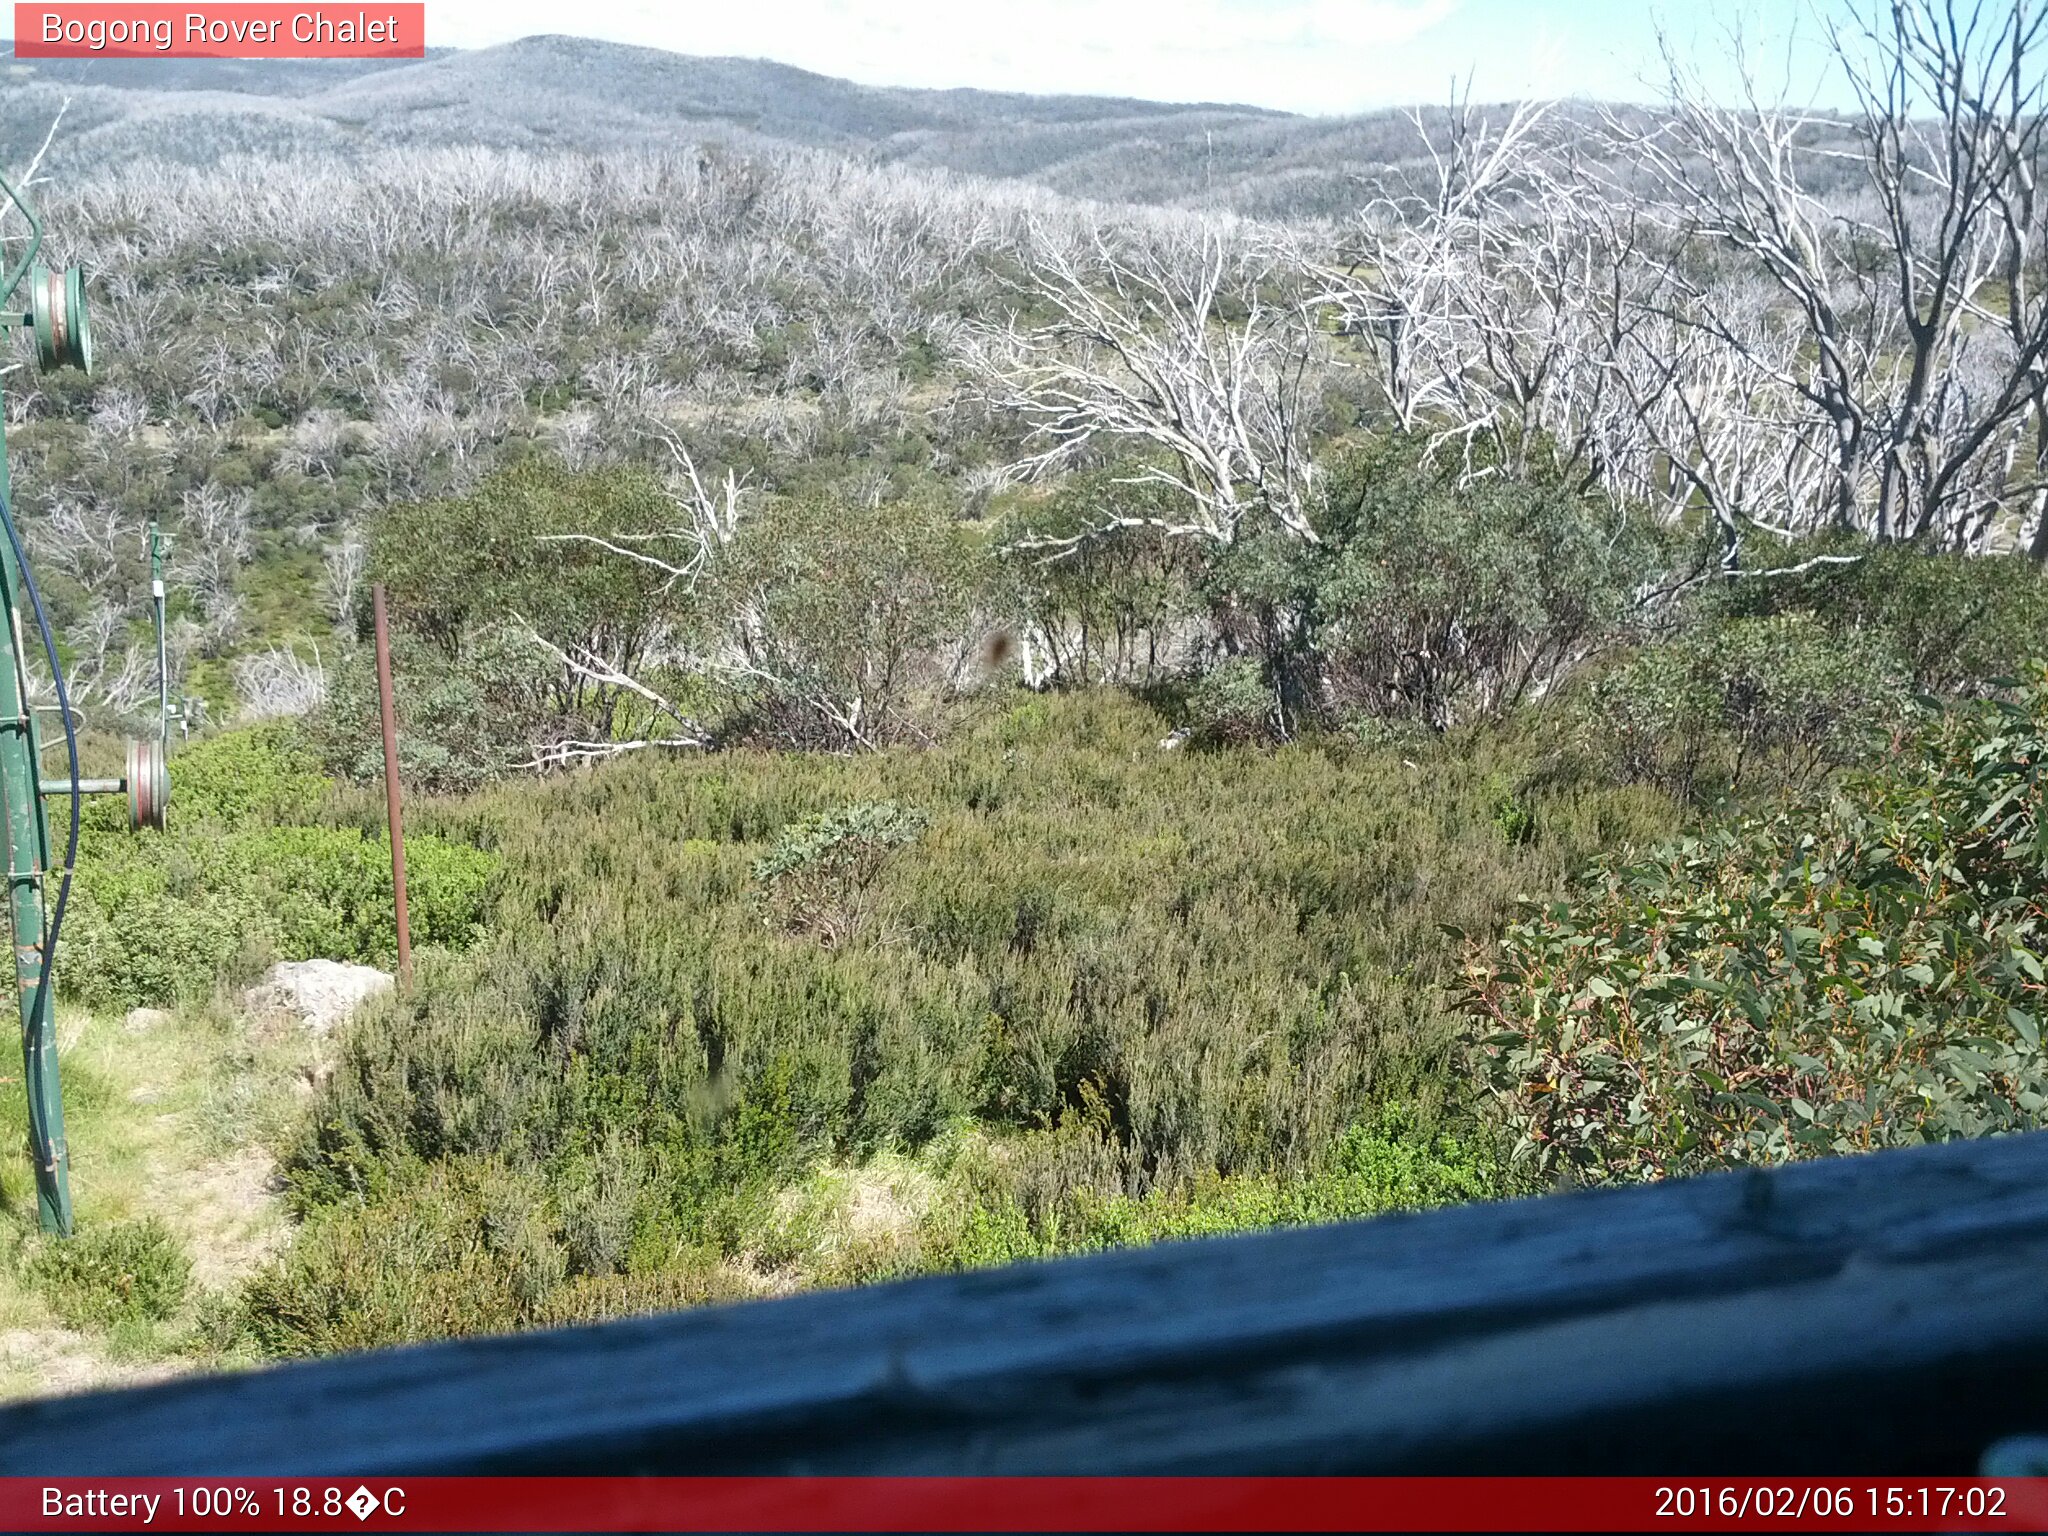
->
[228,694,1671,1352]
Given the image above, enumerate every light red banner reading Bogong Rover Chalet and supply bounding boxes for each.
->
[14,0,426,59]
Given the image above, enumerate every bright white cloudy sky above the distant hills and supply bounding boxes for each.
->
[426,0,1843,115]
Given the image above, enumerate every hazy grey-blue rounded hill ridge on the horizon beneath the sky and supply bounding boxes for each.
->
[0,37,1441,213]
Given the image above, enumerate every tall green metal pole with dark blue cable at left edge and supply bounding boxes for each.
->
[0,399,72,1237]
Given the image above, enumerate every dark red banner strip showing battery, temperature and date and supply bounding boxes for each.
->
[0,1477,2048,1532]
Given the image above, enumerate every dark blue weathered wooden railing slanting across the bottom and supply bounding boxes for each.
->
[0,1135,2048,1477]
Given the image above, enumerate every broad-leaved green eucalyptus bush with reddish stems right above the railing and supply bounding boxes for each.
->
[1468,668,2048,1180]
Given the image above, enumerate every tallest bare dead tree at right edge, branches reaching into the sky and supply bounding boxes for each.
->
[1610,0,2048,545]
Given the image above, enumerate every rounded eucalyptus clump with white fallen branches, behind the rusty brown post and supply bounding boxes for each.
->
[356,475,999,774]
